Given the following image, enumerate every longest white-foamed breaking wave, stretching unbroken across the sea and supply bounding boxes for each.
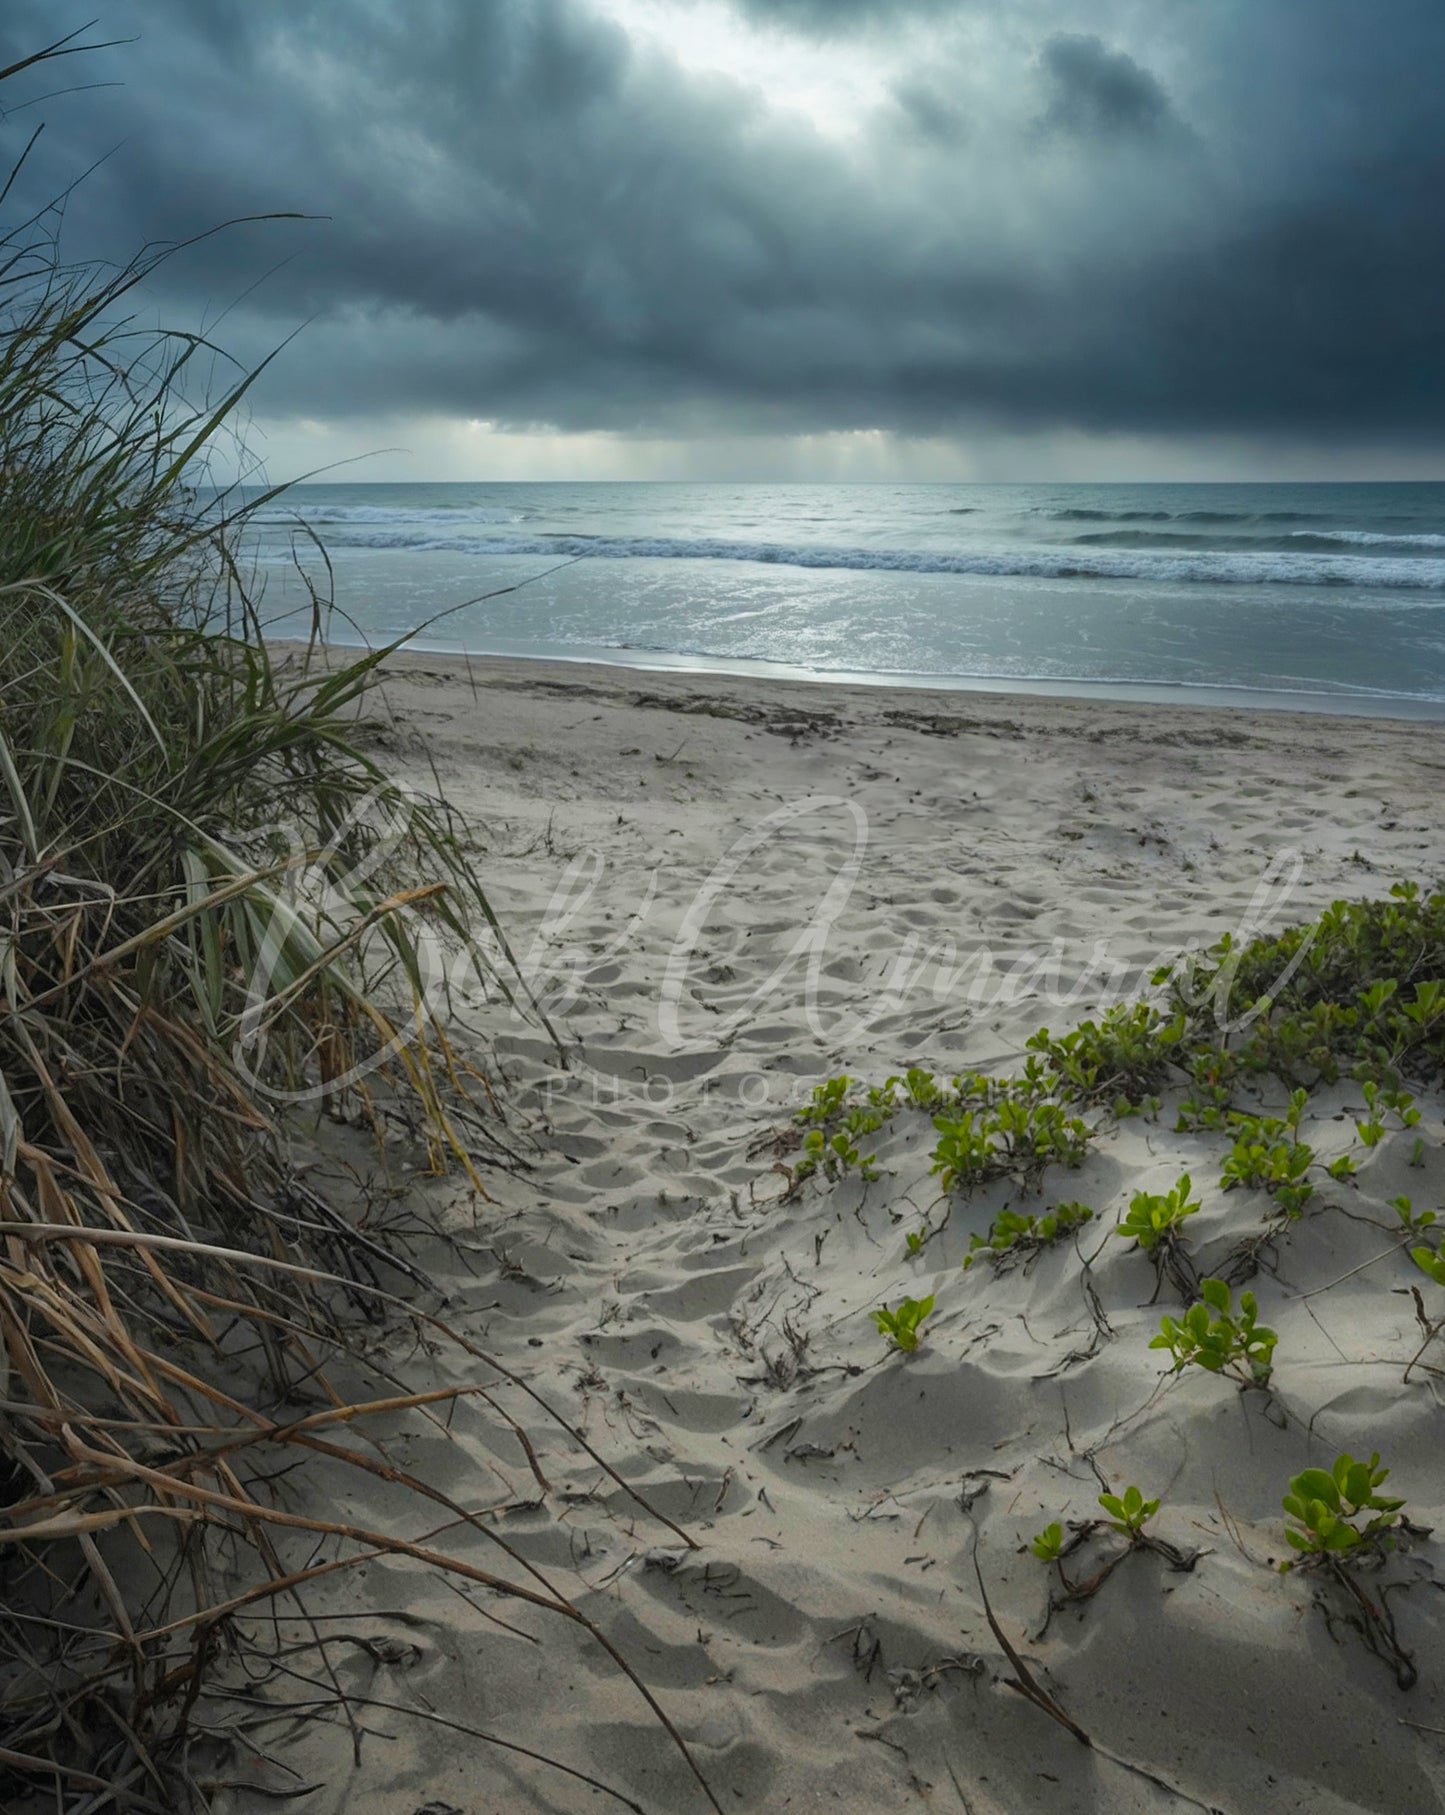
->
[279,528,1445,592]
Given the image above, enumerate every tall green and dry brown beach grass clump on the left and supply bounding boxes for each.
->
[0,40,722,1811]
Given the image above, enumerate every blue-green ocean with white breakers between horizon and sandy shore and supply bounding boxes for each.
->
[243,483,1445,717]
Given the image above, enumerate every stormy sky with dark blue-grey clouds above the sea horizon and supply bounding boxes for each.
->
[0,0,1445,479]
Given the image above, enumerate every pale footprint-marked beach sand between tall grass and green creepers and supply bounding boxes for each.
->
[225,655,1445,1815]
